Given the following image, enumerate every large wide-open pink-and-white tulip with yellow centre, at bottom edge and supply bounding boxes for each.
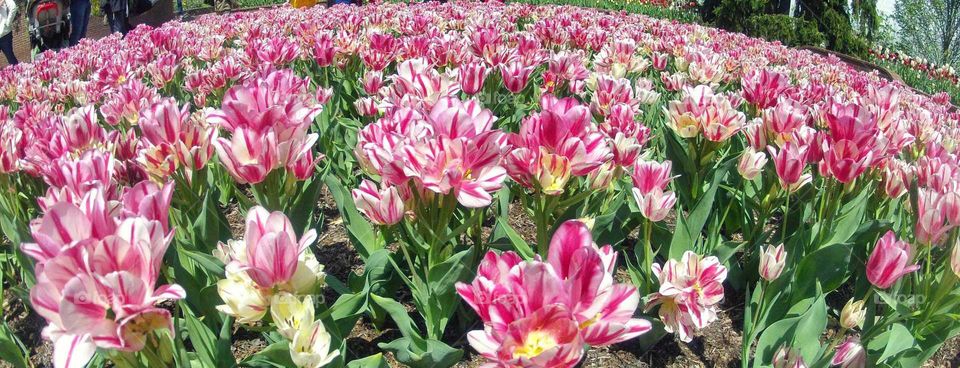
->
[457,221,651,367]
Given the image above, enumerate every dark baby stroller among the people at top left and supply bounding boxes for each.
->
[27,0,70,52]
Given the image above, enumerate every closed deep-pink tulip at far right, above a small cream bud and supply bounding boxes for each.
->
[867,231,920,289]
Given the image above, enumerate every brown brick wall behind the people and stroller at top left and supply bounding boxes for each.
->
[0,0,176,67]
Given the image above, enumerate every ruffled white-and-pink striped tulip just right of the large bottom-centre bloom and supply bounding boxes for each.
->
[645,251,727,342]
